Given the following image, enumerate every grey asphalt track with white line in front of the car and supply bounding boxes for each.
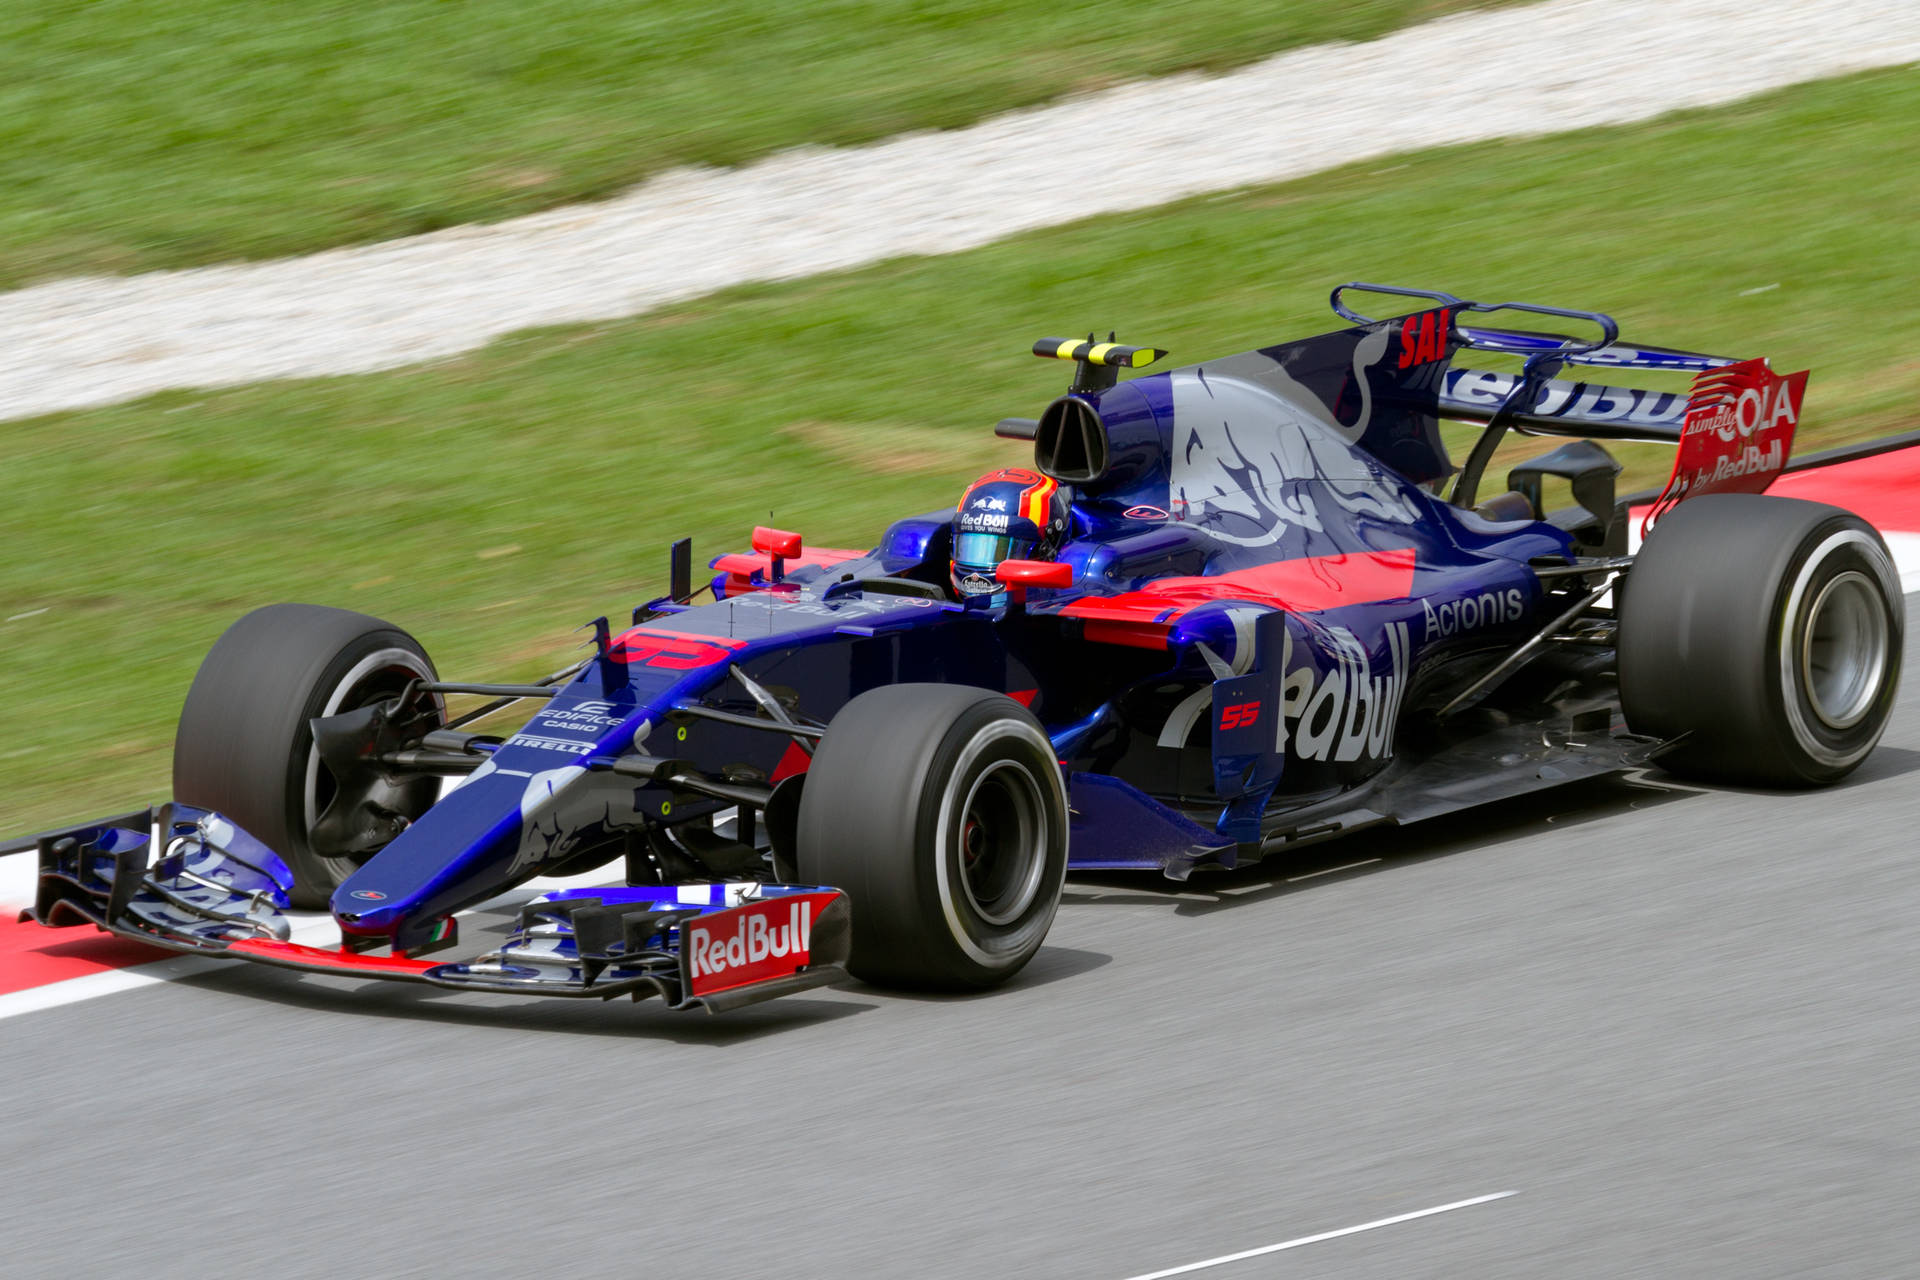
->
[0,597,1920,1280]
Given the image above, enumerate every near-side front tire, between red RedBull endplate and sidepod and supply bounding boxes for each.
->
[795,685,1068,990]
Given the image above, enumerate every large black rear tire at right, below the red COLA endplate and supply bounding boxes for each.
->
[1619,493,1907,787]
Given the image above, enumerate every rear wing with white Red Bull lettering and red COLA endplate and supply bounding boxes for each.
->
[1331,280,1807,520]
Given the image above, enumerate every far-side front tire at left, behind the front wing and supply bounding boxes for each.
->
[173,604,438,908]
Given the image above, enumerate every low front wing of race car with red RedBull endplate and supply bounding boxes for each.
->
[0,804,852,1011]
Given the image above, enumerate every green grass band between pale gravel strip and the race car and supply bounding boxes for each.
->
[0,69,1920,831]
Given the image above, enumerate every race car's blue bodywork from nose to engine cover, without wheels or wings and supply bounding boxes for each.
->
[332,293,1574,946]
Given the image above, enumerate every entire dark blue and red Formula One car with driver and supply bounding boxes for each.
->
[0,284,1905,1009]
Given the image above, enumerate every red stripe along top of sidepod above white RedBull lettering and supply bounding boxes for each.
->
[1060,547,1413,649]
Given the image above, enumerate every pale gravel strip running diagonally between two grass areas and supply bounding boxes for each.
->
[0,0,1920,418]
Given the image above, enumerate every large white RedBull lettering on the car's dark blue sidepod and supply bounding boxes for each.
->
[1275,622,1409,762]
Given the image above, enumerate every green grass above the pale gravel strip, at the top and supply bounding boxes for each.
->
[0,0,1513,288]
